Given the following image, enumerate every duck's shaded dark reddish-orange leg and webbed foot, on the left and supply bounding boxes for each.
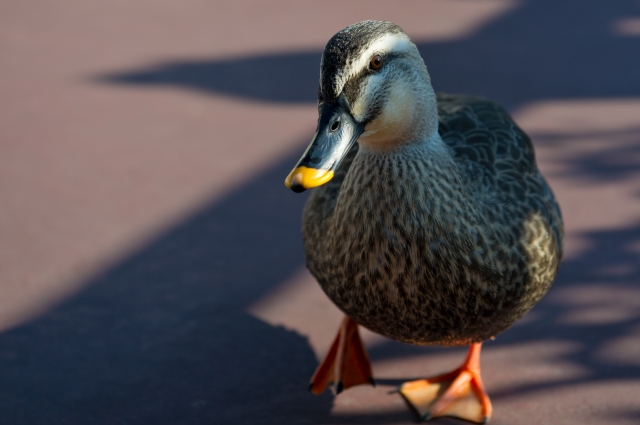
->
[309,316,374,394]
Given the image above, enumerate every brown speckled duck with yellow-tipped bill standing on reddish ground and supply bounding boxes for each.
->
[285,20,564,423]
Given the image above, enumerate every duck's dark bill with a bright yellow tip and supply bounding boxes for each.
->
[284,94,364,192]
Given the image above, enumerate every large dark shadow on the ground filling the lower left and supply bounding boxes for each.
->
[0,151,338,424]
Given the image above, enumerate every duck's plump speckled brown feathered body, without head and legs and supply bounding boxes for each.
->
[303,95,563,345]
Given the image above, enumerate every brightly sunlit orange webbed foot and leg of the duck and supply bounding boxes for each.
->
[400,342,492,423]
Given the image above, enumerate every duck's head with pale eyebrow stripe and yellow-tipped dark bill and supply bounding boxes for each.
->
[285,21,438,192]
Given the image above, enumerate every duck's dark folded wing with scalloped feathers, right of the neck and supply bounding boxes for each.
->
[437,94,563,255]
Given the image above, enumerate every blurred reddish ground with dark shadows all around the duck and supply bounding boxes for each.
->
[0,0,640,424]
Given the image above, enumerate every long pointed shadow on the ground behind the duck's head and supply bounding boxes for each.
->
[97,0,640,108]
